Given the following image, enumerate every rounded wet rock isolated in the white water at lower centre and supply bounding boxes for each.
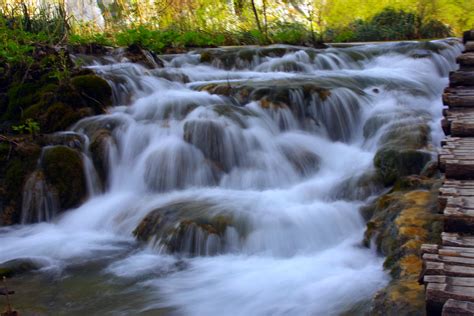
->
[134,201,247,256]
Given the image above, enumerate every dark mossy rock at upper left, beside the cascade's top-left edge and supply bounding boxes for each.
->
[71,75,112,108]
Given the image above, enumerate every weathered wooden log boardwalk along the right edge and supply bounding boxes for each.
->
[420,30,474,316]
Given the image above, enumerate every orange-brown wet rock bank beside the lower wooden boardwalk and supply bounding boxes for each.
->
[364,176,442,315]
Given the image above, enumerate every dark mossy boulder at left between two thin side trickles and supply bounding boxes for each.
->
[41,146,87,210]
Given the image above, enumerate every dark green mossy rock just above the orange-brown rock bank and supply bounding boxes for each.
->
[374,149,431,186]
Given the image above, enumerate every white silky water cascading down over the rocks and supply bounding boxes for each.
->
[0,40,461,315]
